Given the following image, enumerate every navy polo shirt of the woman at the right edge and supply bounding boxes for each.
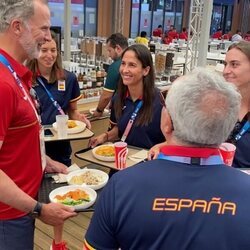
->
[227,114,250,168]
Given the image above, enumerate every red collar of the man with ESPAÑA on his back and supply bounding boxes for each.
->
[160,145,220,158]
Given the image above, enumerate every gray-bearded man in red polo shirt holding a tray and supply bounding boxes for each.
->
[0,0,76,250]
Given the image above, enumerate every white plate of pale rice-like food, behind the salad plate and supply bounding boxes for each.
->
[66,168,109,190]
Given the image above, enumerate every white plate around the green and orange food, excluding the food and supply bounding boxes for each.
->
[49,185,97,209]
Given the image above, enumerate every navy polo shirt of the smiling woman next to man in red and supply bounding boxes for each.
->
[34,70,81,125]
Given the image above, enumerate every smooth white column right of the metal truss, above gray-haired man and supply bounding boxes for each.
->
[197,0,213,67]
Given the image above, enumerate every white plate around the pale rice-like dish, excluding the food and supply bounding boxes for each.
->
[66,168,109,190]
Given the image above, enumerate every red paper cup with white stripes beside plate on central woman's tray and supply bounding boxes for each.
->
[114,141,128,169]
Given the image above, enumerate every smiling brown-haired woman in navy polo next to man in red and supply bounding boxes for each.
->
[27,32,90,166]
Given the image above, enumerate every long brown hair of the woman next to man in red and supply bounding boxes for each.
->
[26,31,65,85]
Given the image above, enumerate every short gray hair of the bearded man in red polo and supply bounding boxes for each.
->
[0,0,47,33]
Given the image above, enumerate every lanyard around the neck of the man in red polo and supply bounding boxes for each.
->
[0,54,40,122]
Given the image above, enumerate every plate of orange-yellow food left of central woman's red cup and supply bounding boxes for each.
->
[92,144,115,161]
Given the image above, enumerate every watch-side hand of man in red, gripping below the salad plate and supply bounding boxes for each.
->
[39,203,77,226]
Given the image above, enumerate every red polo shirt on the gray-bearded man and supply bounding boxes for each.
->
[0,49,42,220]
